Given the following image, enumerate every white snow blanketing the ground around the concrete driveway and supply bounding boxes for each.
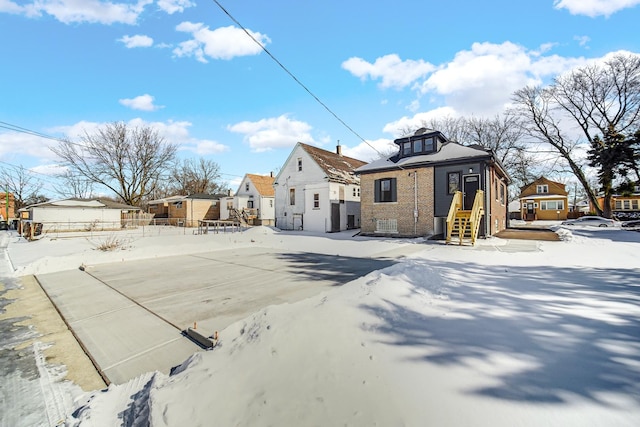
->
[1,225,640,426]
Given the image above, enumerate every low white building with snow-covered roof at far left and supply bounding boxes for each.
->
[19,198,141,237]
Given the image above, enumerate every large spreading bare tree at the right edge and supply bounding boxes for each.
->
[514,54,640,216]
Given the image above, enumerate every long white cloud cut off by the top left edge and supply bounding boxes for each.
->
[10,0,153,25]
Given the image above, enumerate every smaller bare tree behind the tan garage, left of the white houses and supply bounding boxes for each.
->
[169,157,227,195]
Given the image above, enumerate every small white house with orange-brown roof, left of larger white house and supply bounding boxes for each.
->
[220,173,276,225]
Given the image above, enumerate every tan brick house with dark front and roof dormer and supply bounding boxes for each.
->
[356,128,510,241]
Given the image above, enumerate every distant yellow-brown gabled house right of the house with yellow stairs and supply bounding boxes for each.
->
[519,177,569,221]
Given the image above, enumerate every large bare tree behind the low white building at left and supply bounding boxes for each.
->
[52,122,177,206]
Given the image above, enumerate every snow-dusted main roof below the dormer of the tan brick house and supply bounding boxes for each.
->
[356,141,493,173]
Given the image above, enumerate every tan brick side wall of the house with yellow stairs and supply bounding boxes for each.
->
[360,168,434,237]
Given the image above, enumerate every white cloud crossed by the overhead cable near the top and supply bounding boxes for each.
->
[173,22,271,62]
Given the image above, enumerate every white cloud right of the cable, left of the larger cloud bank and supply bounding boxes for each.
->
[342,54,435,89]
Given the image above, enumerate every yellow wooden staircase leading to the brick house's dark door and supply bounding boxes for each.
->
[447,190,484,245]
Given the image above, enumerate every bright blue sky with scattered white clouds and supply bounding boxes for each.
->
[0,0,640,193]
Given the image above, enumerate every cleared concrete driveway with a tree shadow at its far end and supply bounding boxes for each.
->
[37,247,394,384]
